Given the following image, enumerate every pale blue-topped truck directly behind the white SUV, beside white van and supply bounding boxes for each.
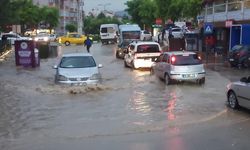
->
[116,24,141,58]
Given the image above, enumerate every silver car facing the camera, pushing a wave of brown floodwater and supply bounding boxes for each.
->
[54,53,102,85]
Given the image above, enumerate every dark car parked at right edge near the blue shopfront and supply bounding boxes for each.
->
[228,45,250,68]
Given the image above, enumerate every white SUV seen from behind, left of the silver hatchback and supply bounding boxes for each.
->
[124,41,161,69]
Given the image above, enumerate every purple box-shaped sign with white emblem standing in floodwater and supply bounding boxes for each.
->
[15,40,38,67]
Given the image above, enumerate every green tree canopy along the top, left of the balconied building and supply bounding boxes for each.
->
[125,0,202,26]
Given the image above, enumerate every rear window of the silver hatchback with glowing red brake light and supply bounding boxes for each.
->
[172,54,202,65]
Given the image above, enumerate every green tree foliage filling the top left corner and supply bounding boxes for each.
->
[0,0,59,32]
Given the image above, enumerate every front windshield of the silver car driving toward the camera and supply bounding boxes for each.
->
[60,56,96,68]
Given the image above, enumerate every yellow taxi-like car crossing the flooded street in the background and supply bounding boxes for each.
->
[57,33,87,46]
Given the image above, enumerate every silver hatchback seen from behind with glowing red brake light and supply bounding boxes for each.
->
[151,51,206,85]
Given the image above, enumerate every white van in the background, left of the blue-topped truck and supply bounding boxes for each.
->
[100,24,118,44]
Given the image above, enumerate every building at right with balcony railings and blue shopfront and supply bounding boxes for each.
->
[199,0,250,54]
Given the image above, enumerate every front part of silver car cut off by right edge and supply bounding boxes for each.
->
[226,76,250,109]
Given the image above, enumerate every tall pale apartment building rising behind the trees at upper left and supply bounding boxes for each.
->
[33,0,84,34]
